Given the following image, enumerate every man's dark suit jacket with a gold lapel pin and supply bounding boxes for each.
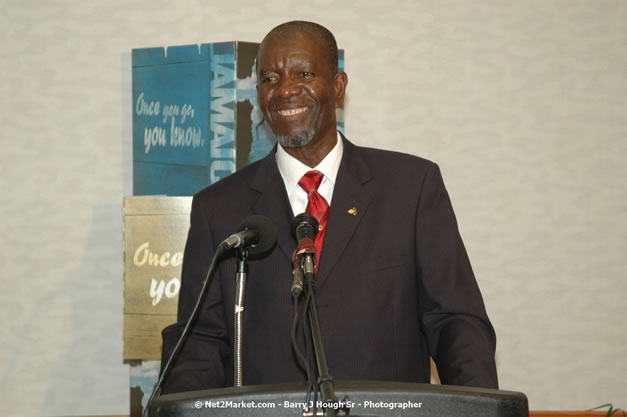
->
[163,139,497,393]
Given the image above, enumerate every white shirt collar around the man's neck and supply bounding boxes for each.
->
[276,132,344,195]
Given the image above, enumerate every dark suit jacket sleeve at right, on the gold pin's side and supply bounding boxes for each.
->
[416,164,498,388]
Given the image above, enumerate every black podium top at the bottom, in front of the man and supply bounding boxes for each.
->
[148,381,529,417]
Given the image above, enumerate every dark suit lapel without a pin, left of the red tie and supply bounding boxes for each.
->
[251,147,296,262]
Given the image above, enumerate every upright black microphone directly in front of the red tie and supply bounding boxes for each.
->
[290,213,318,297]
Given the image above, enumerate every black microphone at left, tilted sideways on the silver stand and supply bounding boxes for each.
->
[218,215,276,253]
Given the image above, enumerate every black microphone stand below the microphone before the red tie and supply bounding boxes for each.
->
[303,253,338,417]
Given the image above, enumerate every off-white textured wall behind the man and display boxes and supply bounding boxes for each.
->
[0,0,627,417]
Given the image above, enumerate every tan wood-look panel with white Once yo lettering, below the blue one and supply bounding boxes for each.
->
[124,197,191,361]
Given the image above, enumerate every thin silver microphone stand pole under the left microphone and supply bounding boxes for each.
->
[233,247,248,387]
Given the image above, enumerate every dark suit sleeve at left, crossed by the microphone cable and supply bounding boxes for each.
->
[161,197,231,394]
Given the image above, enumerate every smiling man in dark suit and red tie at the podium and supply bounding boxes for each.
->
[163,22,498,392]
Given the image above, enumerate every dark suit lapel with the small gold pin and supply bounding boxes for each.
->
[316,137,372,288]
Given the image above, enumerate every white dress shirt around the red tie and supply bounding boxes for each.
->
[276,132,344,215]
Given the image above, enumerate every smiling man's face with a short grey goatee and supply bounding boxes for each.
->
[257,32,345,148]
